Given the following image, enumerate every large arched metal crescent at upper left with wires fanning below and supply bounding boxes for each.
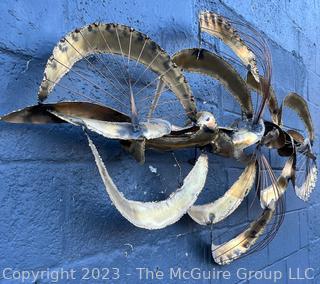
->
[38,23,196,119]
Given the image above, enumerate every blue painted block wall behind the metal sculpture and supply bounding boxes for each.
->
[0,0,320,283]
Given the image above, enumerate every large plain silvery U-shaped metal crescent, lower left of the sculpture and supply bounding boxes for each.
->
[88,133,208,230]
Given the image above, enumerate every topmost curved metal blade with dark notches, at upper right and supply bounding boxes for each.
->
[199,11,259,82]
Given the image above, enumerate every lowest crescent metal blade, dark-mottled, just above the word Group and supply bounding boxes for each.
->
[211,203,275,265]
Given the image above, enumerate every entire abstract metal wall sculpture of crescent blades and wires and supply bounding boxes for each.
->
[1,11,317,265]
